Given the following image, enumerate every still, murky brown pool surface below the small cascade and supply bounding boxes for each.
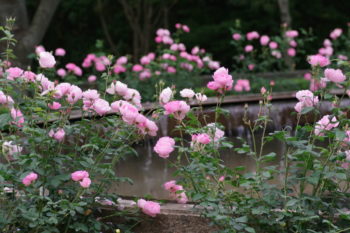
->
[114,139,284,199]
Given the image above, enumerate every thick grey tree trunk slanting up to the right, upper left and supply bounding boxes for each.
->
[15,0,61,66]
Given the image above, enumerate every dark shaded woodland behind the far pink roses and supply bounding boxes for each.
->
[0,0,350,66]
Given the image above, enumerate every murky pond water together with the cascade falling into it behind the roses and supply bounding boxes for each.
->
[113,100,349,199]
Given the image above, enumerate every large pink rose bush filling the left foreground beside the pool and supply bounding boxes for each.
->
[0,20,159,233]
